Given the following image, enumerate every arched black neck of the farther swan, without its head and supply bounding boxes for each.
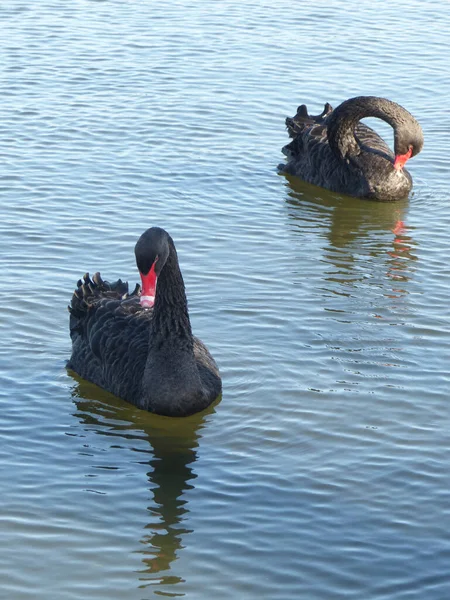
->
[327,96,416,159]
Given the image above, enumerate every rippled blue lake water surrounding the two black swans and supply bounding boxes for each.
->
[0,0,450,600]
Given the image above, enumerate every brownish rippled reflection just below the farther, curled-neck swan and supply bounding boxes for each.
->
[284,175,417,298]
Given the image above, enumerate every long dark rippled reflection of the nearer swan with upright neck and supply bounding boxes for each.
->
[69,371,217,596]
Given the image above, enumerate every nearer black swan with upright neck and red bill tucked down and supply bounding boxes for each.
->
[67,227,222,417]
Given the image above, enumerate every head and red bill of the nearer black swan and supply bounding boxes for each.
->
[134,227,170,308]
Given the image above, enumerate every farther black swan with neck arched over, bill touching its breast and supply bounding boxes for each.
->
[280,96,423,201]
